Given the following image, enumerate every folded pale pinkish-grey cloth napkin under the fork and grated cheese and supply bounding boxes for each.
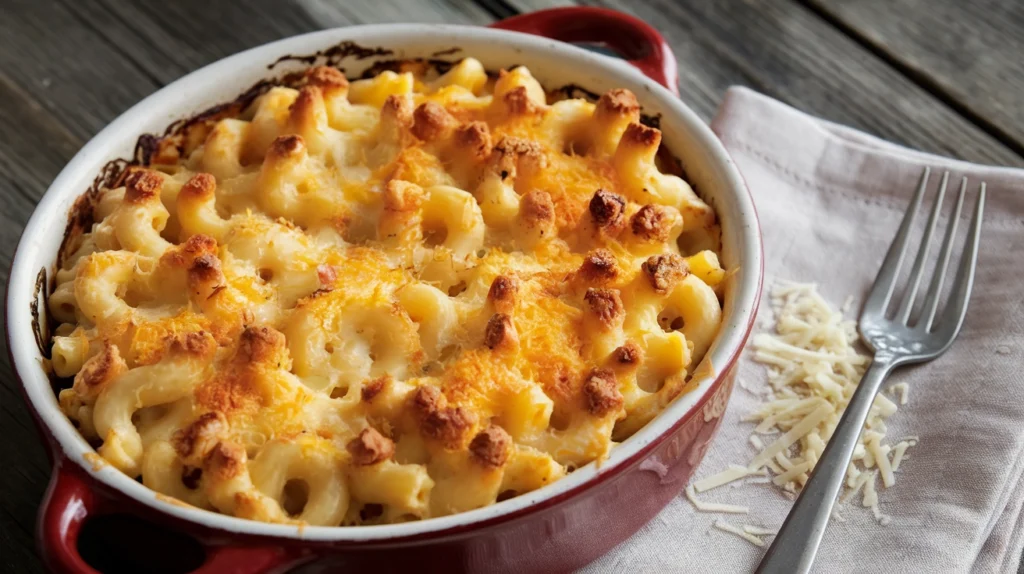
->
[588,88,1024,573]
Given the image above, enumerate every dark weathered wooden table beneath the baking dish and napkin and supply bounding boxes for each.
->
[0,0,1024,572]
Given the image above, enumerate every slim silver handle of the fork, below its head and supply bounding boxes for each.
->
[757,356,893,574]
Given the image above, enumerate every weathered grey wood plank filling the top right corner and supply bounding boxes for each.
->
[801,0,1024,158]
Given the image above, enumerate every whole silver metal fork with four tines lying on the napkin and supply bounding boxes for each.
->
[757,168,985,574]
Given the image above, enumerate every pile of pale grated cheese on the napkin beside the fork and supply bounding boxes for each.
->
[687,282,918,545]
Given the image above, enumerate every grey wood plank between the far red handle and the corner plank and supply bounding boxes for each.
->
[510,0,1024,166]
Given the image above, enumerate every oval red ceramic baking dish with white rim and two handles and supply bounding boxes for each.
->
[6,8,763,574]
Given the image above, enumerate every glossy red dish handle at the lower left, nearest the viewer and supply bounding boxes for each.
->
[37,456,301,574]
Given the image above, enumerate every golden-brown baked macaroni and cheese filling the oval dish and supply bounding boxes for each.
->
[49,58,725,526]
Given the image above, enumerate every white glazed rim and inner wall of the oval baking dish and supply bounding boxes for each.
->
[7,25,761,541]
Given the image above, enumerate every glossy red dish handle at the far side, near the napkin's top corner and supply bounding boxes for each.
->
[489,6,679,96]
